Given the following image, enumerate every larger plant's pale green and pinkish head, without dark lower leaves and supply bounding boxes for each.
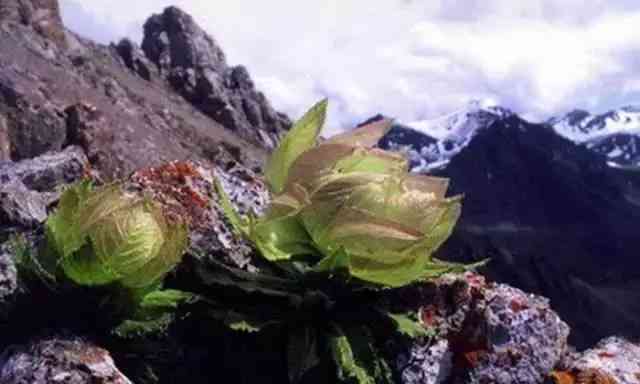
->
[219,101,461,287]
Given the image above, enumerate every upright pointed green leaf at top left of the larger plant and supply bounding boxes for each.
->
[265,99,328,194]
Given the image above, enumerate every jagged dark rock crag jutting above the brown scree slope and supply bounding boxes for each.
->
[142,7,290,148]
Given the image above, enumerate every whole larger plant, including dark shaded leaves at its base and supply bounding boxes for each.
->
[212,101,478,384]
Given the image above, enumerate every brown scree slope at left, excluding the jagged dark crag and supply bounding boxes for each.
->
[0,0,266,179]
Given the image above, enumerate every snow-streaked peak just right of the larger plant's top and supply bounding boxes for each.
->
[381,101,513,172]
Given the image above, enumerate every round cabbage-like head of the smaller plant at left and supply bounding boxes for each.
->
[46,181,188,289]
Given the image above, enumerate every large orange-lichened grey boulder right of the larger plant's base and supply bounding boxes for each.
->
[396,273,569,384]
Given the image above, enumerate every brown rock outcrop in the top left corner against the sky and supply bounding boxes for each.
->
[0,0,66,47]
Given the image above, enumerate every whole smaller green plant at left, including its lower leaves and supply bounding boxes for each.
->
[21,180,193,335]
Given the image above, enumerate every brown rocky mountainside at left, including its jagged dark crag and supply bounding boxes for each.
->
[0,0,290,179]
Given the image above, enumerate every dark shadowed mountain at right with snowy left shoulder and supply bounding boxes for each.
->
[380,104,640,347]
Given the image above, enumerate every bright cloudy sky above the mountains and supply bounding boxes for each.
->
[60,0,640,133]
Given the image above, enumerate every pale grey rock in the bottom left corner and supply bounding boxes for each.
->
[0,337,131,384]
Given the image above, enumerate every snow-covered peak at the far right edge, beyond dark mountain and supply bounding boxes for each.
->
[548,106,640,167]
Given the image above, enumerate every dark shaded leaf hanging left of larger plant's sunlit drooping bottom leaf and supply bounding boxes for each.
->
[287,325,320,384]
